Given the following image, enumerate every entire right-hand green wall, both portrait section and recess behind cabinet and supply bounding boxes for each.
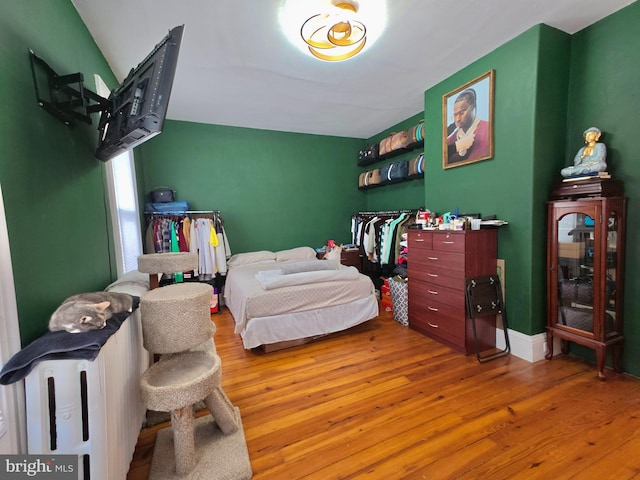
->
[425,2,640,375]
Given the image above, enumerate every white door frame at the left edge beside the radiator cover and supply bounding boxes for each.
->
[0,186,27,454]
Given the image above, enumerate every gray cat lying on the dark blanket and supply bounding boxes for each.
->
[49,292,133,333]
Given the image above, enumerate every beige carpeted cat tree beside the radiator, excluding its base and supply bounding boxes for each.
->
[138,254,246,478]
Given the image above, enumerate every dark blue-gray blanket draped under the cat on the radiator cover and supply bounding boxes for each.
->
[0,296,140,385]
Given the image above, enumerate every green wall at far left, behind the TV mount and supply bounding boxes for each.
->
[0,0,115,344]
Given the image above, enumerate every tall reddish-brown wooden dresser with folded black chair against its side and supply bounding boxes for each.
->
[408,229,498,355]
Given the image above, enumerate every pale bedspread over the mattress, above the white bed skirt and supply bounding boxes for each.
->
[224,263,374,333]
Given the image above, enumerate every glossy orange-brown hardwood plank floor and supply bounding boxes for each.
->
[127,309,640,480]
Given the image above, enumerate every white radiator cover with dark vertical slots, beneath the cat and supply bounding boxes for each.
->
[25,278,150,480]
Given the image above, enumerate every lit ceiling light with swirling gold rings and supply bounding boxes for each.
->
[300,2,367,62]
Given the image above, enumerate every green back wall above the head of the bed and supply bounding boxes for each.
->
[136,121,365,253]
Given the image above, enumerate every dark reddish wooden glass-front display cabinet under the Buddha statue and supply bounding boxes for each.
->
[546,187,626,380]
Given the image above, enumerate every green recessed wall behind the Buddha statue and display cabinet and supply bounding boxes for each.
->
[566,2,640,375]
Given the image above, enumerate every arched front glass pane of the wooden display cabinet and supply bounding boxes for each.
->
[556,213,596,335]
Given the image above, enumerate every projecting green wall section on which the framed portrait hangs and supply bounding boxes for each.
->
[425,25,570,335]
